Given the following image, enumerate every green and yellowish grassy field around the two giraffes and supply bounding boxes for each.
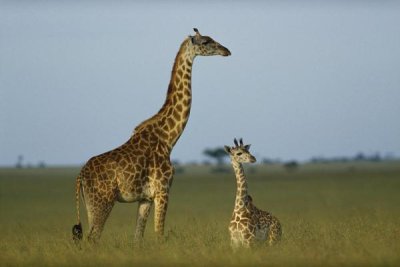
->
[0,162,400,266]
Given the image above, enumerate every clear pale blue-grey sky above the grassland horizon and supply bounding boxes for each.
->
[0,0,400,166]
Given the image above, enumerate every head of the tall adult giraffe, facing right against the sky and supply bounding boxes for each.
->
[189,28,231,57]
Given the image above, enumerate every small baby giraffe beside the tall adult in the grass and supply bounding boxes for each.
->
[225,139,282,248]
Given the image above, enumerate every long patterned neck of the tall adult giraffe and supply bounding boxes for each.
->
[135,38,195,149]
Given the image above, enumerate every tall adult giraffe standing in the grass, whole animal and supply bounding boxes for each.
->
[73,29,230,241]
